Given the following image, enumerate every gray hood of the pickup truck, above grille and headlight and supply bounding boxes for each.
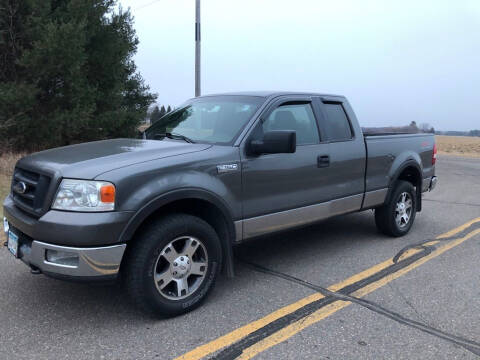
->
[17,139,211,179]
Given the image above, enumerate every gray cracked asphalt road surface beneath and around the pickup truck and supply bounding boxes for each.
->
[0,157,480,359]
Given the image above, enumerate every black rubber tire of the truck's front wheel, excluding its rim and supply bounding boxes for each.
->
[123,214,222,317]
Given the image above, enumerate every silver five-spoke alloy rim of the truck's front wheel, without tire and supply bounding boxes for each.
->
[153,236,208,300]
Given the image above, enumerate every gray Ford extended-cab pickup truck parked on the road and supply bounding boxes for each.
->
[3,92,437,316]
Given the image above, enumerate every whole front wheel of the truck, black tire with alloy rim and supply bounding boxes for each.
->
[126,214,222,317]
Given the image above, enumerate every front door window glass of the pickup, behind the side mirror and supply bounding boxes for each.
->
[262,103,320,145]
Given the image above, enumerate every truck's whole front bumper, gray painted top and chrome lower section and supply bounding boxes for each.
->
[3,196,132,280]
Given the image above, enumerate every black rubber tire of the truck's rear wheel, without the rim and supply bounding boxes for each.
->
[375,180,417,237]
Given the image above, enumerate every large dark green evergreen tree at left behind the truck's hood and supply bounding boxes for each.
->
[0,0,156,150]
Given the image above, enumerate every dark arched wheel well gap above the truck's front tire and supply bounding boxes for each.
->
[124,198,235,276]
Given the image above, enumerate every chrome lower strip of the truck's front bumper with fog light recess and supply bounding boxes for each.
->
[6,221,126,280]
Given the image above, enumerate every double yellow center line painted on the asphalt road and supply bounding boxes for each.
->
[176,218,480,360]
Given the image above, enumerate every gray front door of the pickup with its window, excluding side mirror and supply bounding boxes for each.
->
[241,97,330,238]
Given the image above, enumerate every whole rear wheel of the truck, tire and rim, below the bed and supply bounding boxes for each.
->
[375,180,417,237]
